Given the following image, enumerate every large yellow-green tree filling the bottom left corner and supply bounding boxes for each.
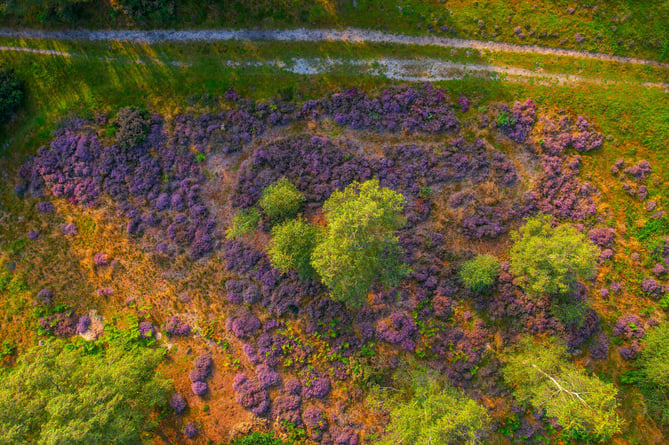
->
[0,339,172,445]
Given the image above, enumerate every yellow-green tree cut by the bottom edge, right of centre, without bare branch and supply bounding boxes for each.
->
[370,371,490,445]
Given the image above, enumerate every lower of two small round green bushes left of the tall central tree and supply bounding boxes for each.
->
[267,218,319,278]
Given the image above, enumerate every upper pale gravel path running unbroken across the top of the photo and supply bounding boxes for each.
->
[0,28,669,68]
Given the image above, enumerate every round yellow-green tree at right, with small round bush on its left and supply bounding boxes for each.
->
[511,215,599,296]
